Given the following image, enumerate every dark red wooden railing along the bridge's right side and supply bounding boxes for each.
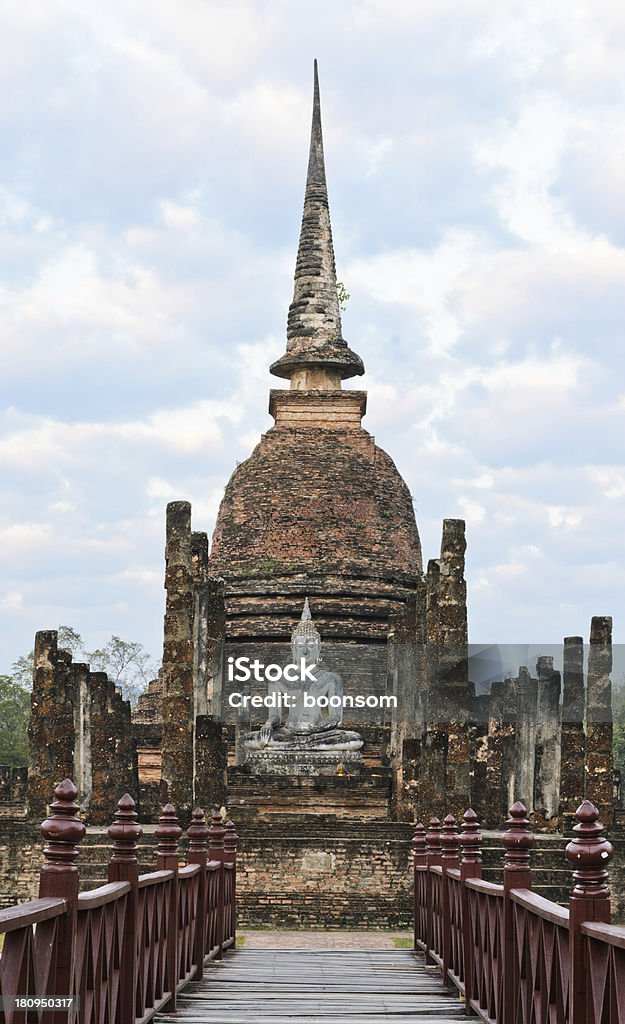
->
[412,801,614,1024]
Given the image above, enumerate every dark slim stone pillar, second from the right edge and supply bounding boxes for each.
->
[559,637,586,831]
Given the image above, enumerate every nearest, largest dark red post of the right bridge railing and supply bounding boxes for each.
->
[567,800,614,1024]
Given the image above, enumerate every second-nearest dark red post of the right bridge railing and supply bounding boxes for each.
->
[498,801,534,1024]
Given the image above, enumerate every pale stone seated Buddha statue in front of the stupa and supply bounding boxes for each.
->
[245,598,363,752]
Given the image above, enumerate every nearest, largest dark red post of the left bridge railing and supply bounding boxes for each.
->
[39,778,86,1024]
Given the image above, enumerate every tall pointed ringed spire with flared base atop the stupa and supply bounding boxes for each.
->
[270,60,365,390]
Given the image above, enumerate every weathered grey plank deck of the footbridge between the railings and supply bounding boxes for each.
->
[155,948,465,1024]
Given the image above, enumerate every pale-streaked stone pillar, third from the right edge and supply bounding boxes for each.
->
[532,656,560,828]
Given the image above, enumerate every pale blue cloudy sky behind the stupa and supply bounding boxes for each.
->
[0,0,625,672]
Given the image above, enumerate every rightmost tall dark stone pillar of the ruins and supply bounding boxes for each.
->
[586,615,614,824]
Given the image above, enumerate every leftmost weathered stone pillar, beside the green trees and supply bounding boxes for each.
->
[28,630,74,819]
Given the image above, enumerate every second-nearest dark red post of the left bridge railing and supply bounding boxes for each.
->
[108,793,143,1021]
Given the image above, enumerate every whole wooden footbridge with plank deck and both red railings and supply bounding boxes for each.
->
[0,779,625,1024]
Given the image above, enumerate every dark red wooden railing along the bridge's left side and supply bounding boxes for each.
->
[0,779,238,1024]
